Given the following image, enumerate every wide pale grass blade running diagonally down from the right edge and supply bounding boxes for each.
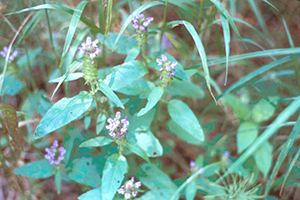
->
[217,96,300,182]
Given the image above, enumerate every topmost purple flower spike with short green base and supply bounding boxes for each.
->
[132,14,153,46]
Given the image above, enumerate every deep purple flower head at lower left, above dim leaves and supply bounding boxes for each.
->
[45,140,66,165]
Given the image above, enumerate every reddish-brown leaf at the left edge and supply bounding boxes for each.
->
[0,103,24,151]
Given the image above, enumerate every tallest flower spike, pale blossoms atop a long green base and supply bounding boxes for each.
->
[78,37,101,92]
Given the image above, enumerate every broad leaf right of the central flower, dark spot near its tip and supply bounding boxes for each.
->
[134,129,163,157]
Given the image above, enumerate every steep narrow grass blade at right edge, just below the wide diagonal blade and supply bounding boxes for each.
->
[264,115,300,196]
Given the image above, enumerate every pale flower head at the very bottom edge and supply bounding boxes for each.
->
[118,177,142,199]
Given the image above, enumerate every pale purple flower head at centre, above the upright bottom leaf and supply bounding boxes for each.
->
[106,112,129,142]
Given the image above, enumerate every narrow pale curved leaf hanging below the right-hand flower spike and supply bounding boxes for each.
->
[137,86,164,117]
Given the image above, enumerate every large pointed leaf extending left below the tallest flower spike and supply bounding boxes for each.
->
[34,91,93,139]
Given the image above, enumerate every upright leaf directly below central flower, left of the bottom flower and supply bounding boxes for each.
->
[102,154,128,200]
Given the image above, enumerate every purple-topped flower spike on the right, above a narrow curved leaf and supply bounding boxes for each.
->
[156,54,177,87]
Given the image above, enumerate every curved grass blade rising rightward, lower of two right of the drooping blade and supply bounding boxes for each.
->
[217,56,292,99]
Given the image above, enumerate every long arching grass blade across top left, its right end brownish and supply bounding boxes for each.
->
[5,4,104,33]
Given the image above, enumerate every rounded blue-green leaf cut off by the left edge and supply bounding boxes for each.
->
[0,74,23,96]
